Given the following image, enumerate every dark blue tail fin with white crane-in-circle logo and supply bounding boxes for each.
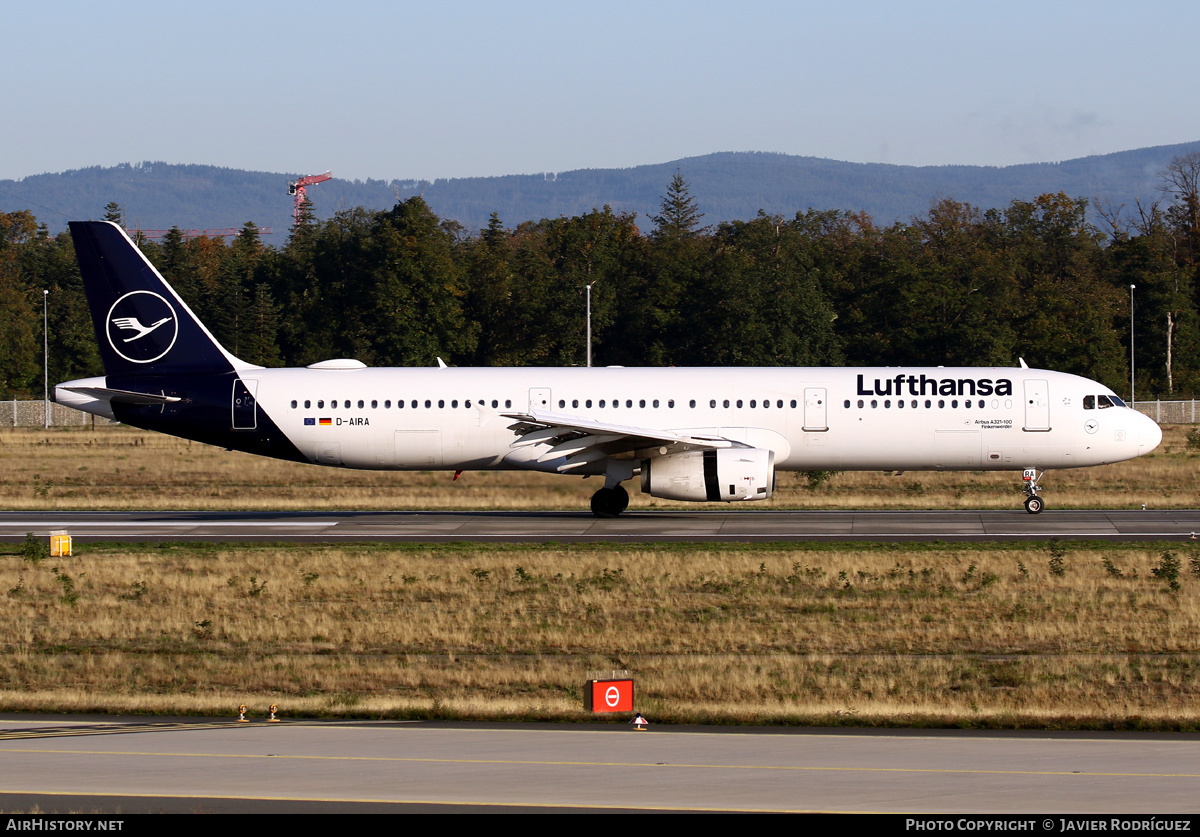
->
[70,221,253,378]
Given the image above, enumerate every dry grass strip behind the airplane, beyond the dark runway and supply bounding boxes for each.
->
[7,419,1200,510]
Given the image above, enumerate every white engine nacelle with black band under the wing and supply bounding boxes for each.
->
[642,447,775,502]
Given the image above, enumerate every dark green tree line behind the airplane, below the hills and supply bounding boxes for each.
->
[0,155,1200,399]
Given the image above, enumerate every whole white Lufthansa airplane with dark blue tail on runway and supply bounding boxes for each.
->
[55,221,1163,517]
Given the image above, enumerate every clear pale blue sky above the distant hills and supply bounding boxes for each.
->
[0,0,1200,180]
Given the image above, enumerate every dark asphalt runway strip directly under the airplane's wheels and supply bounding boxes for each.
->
[0,510,1200,543]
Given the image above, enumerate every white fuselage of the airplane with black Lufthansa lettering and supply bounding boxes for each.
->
[240,368,1162,474]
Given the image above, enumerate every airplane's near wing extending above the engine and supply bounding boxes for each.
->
[500,410,745,472]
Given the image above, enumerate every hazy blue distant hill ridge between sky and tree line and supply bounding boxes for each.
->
[0,141,1200,243]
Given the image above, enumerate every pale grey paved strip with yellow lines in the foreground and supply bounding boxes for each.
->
[0,717,1200,815]
